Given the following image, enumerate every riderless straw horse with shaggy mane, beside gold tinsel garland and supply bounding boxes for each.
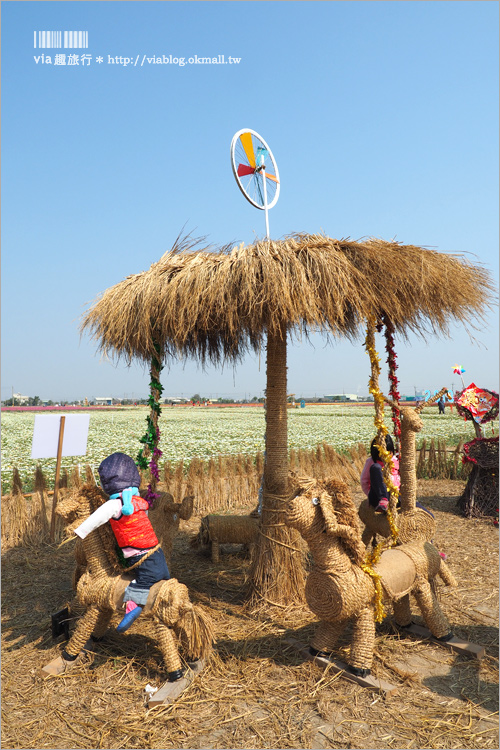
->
[286,476,455,675]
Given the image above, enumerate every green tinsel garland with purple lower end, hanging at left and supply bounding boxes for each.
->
[137,345,163,507]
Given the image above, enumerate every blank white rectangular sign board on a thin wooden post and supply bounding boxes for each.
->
[31,414,90,458]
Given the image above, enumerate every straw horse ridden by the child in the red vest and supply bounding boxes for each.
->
[57,485,213,680]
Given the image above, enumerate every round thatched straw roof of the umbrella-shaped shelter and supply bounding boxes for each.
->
[81,234,494,363]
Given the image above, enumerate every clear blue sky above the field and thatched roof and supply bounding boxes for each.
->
[1,1,498,400]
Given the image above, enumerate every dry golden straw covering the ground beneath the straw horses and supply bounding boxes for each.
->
[2,480,498,748]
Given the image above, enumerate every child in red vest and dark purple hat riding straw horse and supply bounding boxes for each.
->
[75,453,170,633]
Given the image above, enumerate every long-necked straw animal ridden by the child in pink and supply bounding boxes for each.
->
[358,388,446,544]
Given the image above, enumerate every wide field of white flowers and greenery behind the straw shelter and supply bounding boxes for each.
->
[2,404,492,492]
